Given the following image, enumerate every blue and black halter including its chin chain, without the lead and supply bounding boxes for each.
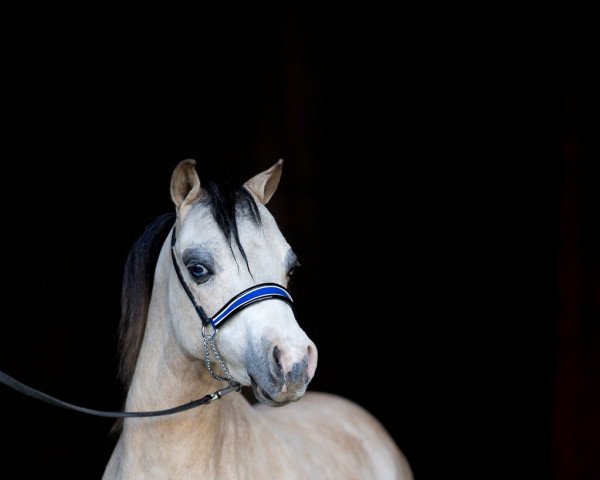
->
[171,227,293,386]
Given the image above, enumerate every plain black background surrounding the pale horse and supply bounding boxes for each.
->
[0,4,600,479]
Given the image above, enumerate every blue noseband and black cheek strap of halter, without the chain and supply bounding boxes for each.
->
[171,227,294,330]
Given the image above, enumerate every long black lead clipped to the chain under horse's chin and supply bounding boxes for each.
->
[0,371,242,418]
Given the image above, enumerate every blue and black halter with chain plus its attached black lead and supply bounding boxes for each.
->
[0,227,293,418]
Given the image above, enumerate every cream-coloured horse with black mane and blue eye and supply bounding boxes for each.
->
[103,160,412,480]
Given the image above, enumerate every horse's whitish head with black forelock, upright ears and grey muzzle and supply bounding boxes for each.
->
[167,160,317,406]
